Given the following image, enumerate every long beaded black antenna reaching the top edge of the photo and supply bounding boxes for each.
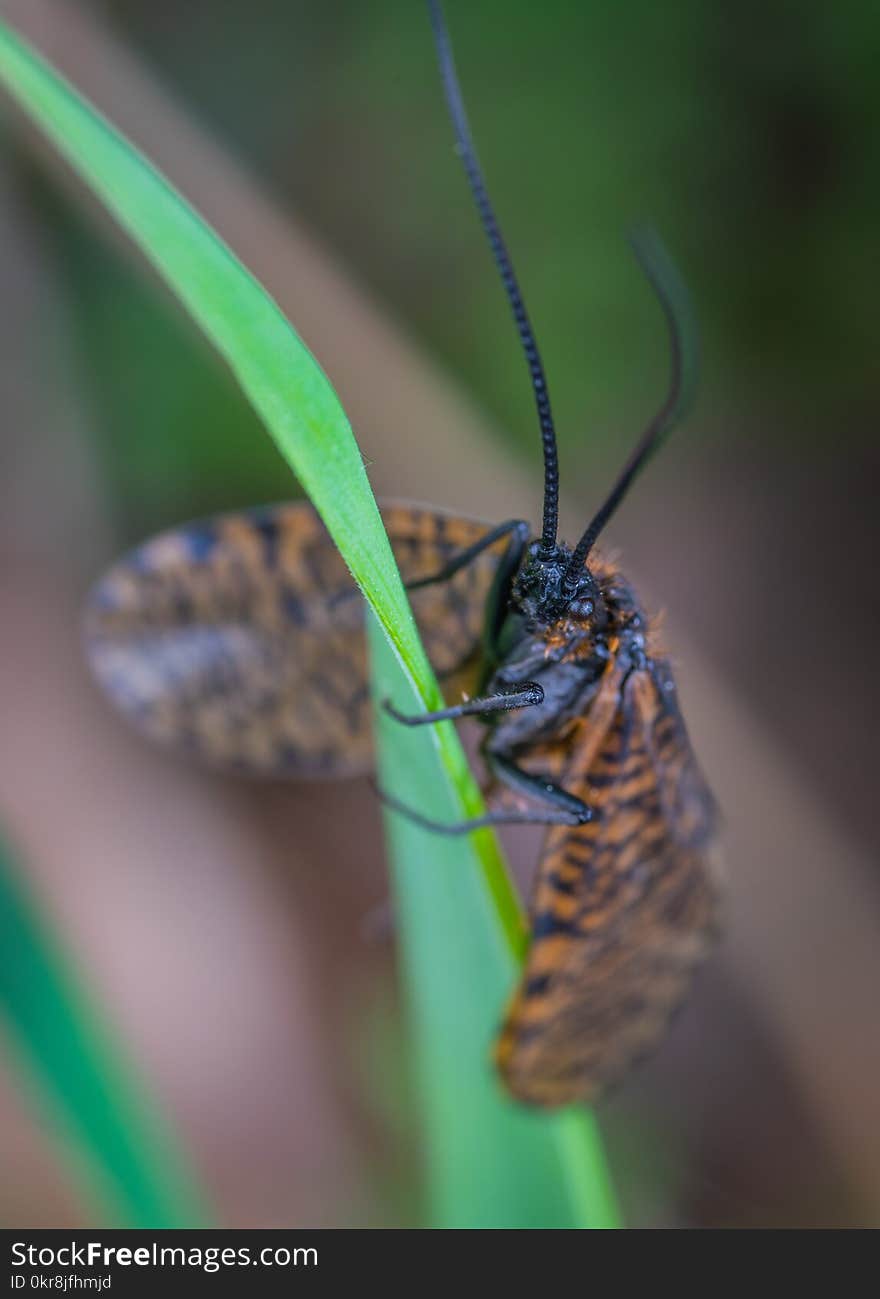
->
[428,0,559,555]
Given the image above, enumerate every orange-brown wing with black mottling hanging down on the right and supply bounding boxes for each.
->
[497,664,718,1105]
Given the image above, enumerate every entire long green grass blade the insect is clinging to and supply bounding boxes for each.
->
[0,15,615,1226]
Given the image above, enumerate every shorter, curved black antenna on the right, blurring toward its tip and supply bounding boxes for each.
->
[564,227,698,591]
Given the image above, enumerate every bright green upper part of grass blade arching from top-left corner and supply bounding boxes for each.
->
[0,17,430,688]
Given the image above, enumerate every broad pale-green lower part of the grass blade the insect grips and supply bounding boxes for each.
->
[372,624,619,1229]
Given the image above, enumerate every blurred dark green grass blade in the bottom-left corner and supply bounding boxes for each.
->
[0,840,208,1228]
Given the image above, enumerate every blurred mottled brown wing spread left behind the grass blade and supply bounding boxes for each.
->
[86,503,503,777]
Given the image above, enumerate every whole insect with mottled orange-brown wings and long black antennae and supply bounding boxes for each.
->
[86,0,716,1107]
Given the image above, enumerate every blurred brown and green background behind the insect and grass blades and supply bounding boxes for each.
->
[0,0,880,1226]
